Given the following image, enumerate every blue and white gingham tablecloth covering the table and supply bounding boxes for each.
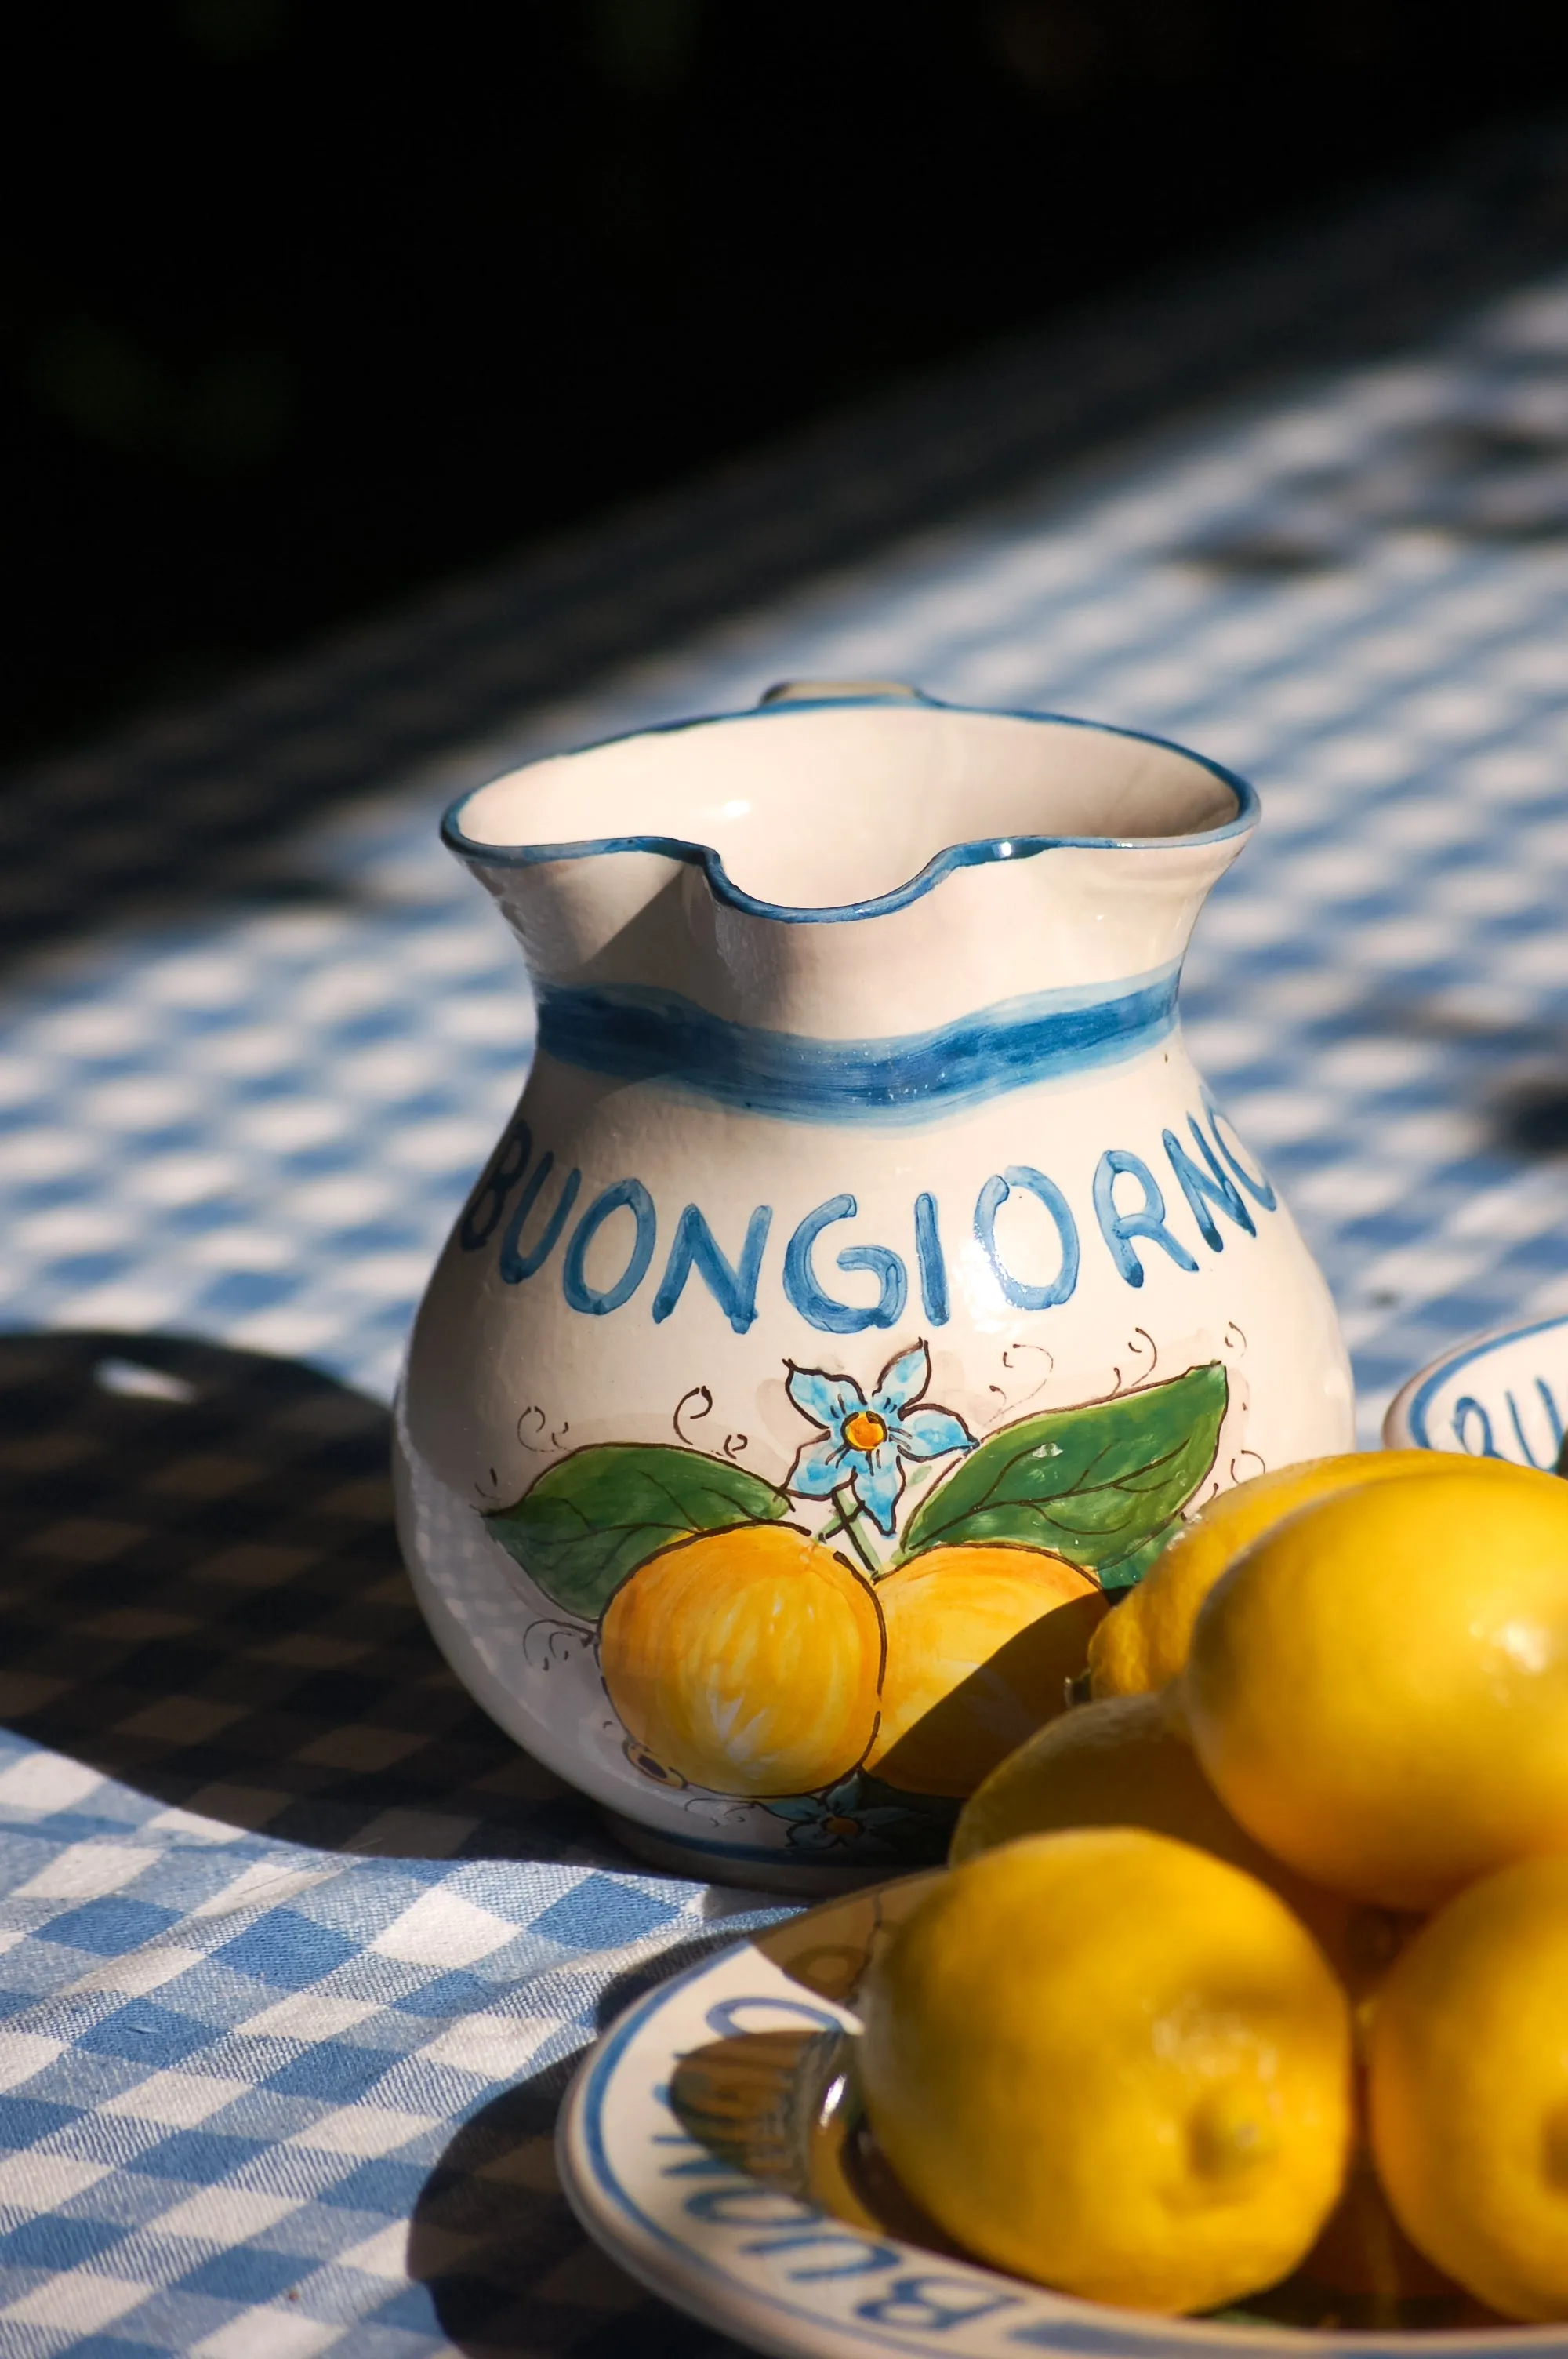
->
[0,157,1568,2359]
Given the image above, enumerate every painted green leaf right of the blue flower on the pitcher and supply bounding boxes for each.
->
[903,1361,1229,1585]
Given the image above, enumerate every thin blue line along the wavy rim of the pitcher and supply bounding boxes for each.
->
[441,696,1257,925]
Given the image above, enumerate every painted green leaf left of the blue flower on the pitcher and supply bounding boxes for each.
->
[486,1441,790,1620]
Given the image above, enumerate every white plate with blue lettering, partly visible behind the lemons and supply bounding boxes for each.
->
[1384,1314,1568,1472]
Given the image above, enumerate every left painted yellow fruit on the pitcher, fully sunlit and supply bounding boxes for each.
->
[599,1524,882,1795]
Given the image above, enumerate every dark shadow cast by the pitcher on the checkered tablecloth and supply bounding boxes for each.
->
[0,1333,630,1866]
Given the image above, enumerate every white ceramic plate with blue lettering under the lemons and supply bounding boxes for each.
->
[559,1870,1568,2359]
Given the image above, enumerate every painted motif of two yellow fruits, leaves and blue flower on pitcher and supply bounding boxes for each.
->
[486,1338,1229,1863]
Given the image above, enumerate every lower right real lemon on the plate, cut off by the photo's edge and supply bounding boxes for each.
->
[1370,1856,1568,2319]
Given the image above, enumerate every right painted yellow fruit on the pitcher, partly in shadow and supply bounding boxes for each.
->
[866,1545,1106,1795]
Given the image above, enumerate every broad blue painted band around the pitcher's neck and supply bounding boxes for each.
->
[540,962,1181,1128]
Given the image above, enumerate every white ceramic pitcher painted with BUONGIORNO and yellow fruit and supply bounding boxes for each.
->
[398,689,1351,1885]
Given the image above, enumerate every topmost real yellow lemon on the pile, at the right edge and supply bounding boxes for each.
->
[1184,1463,1568,1908]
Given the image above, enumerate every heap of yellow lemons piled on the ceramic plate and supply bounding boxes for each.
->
[861,1451,1568,2321]
